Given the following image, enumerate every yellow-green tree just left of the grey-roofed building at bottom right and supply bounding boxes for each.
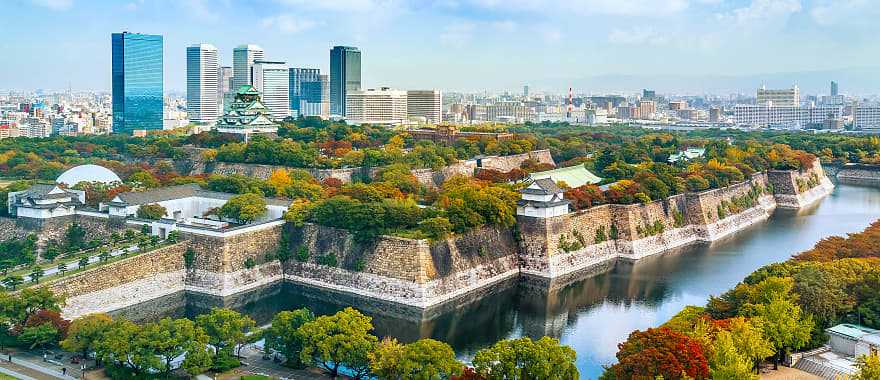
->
[755,297,813,368]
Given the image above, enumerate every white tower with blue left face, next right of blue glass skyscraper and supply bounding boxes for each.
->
[186,44,220,124]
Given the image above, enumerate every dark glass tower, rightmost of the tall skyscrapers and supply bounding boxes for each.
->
[330,46,361,116]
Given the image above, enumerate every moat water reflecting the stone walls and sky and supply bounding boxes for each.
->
[117,185,880,379]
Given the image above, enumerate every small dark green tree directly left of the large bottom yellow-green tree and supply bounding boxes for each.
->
[263,309,315,368]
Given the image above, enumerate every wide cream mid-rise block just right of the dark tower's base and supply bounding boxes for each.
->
[345,87,407,125]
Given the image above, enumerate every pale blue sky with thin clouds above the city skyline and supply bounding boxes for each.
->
[0,0,880,93]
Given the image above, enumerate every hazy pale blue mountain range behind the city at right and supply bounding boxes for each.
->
[533,67,880,96]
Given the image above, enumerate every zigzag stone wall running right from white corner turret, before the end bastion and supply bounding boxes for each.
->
[517,174,775,278]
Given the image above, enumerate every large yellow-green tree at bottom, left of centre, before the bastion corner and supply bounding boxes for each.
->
[299,307,378,379]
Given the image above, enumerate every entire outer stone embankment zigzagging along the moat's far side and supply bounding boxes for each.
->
[49,157,833,317]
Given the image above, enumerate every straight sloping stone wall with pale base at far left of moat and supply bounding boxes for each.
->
[43,242,187,319]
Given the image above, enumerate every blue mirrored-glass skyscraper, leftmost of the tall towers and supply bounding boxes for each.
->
[111,32,164,133]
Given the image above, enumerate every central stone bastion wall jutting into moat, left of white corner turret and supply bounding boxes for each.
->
[284,224,518,307]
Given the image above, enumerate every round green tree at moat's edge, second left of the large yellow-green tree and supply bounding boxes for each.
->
[196,308,256,355]
